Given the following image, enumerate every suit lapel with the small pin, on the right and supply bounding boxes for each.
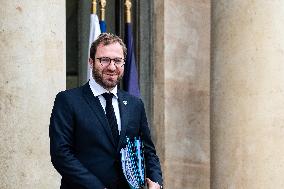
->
[117,91,128,151]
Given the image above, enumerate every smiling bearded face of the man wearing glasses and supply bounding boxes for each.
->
[89,43,124,90]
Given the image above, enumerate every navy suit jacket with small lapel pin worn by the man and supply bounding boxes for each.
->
[49,83,162,189]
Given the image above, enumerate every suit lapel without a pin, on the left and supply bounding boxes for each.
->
[83,83,115,146]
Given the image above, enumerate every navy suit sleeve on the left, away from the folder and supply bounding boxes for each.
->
[49,92,105,189]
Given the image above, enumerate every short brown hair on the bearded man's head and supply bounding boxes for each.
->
[90,33,127,60]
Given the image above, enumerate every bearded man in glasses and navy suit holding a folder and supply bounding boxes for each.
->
[49,33,162,189]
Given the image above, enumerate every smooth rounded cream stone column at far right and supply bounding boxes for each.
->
[211,0,284,189]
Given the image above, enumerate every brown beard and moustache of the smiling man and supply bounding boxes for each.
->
[92,66,123,89]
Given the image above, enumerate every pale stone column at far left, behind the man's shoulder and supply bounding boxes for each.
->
[0,0,66,189]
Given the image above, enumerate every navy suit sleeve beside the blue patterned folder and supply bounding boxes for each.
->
[140,100,163,186]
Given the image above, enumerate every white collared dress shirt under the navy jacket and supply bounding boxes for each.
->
[89,77,121,134]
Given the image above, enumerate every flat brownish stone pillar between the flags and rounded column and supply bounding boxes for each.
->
[153,0,210,189]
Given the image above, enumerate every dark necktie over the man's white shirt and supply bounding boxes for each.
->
[102,93,119,145]
